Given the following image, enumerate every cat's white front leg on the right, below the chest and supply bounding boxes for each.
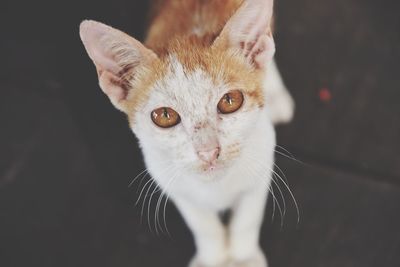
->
[229,188,268,267]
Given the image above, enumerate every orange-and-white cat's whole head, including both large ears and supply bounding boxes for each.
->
[80,0,275,181]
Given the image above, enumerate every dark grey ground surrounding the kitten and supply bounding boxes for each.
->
[0,0,400,267]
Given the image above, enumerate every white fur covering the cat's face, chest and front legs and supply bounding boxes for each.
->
[132,56,275,267]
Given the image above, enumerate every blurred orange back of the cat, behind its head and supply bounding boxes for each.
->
[145,0,243,53]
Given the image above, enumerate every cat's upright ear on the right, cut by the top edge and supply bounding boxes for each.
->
[213,0,275,69]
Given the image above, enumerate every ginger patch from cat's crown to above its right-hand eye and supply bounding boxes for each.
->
[161,36,264,111]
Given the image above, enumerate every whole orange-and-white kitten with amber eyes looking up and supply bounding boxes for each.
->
[80,0,293,267]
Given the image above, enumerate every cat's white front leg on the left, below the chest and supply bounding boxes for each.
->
[174,198,228,267]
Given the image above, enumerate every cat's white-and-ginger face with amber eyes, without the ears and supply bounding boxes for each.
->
[129,49,264,178]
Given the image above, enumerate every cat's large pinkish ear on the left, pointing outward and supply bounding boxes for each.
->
[79,20,157,110]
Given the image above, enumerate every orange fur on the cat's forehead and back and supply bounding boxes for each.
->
[122,0,264,119]
